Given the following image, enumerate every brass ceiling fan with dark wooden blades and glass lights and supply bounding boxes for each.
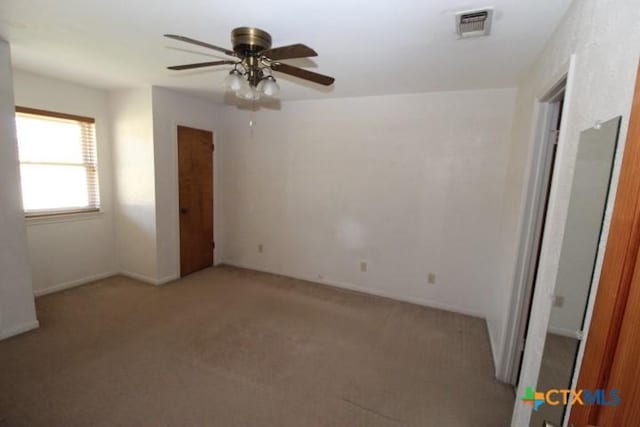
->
[164,27,335,101]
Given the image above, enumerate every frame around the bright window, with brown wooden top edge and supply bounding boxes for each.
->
[15,105,102,219]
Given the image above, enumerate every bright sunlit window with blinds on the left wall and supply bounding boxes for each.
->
[16,107,100,217]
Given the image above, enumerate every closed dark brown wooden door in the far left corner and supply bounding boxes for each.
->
[178,126,214,276]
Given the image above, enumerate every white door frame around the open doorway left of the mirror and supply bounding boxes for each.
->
[496,61,575,385]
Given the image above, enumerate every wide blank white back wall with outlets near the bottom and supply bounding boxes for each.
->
[223,89,515,324]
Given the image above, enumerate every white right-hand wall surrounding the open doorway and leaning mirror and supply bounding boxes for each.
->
[498,0,640,426]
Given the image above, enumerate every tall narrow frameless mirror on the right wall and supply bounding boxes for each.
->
[530,117,620,427]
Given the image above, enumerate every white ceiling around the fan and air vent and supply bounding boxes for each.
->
[0,0,571,102]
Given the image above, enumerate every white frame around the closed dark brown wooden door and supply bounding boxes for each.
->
[171,121,221,278]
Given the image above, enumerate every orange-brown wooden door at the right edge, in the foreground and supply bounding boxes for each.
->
[569,61,640,427]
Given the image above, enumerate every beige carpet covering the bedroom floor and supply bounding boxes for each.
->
[0,267,513,427]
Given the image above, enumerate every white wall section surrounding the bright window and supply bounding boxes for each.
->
[13,70,116,295]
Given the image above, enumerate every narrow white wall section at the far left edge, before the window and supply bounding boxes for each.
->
[0,39,38,339]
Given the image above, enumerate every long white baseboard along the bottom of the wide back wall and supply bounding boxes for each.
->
[221,261,486,321]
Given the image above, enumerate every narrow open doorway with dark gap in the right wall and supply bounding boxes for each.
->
[510,78,567,387]
